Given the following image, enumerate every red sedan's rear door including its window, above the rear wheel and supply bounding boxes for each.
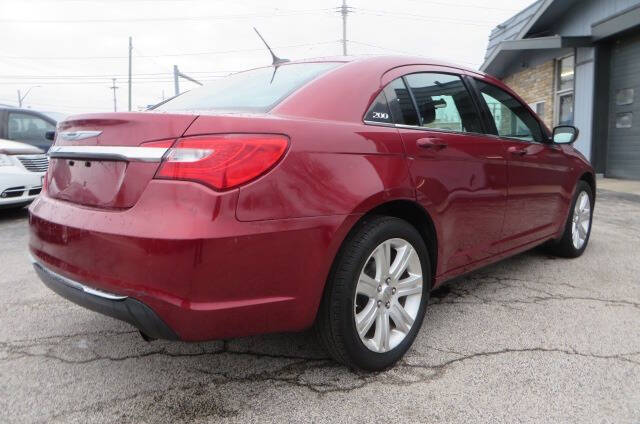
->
[385,71,506,275]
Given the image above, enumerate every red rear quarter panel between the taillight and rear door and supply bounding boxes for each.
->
[185,116,415,221]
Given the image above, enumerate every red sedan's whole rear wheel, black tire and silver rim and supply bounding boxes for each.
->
[316,216,431,371]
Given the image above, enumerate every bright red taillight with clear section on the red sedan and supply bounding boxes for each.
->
[155,134,289,190]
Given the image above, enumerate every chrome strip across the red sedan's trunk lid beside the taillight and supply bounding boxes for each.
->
[48,146,169,162]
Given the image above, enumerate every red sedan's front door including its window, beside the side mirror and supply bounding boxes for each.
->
[473,80,569,250]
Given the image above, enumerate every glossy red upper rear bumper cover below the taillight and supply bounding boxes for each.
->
[29,180,358,341]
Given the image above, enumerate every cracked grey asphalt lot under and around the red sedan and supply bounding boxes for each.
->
[0,191,640,423]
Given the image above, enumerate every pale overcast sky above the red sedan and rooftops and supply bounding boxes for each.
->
[0,0,532,113]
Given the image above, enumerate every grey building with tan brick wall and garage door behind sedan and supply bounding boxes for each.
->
[481,0,640,179]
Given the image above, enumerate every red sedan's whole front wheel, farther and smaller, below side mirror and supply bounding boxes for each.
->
[549,180,593,258]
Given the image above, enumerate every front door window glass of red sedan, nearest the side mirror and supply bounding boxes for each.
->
[476,81,544,142]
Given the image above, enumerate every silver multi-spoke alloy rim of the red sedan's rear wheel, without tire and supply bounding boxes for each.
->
[353,238,423,353]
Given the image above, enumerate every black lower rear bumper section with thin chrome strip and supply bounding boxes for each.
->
[32,258,178,340]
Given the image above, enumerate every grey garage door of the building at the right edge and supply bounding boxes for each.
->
[606,34,640,180]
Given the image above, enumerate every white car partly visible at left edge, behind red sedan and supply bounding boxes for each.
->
[0,139,49,209]
